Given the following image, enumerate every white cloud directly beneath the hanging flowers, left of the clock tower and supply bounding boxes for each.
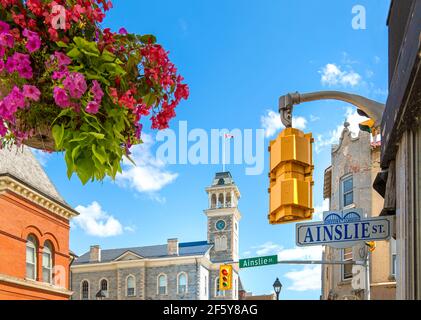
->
[116,134,178,194]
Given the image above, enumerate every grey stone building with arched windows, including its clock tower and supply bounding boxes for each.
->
[71,172,241,300]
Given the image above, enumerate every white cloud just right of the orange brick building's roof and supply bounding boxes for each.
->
[72,201,127,238]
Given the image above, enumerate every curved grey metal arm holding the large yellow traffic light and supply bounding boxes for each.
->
[279,91,385,128]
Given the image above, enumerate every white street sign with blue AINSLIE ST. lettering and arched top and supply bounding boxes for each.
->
[296,209,392,248]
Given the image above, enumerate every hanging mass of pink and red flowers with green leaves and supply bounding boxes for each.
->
[0,0,189,184]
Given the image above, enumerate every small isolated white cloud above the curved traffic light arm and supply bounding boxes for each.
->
[319,63,362,87]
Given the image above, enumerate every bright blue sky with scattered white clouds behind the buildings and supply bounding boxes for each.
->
[34,0,389,299]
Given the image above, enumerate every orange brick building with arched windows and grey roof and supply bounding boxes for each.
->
[0,147,77,300]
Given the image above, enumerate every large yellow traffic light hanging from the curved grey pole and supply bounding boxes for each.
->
[269,128,314,224]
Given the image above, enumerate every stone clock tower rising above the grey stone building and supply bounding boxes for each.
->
[205,172,241,263]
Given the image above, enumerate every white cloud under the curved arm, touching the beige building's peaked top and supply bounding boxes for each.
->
[316,107,367,153]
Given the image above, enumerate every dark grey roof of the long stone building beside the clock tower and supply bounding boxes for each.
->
[73,241,212,266]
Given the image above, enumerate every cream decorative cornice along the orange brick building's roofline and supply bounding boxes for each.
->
[0,174,79,220]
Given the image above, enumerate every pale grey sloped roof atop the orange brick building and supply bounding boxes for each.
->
[0,146,67,205]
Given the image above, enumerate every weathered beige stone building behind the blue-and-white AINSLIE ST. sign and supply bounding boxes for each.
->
[322,123,396,300]
